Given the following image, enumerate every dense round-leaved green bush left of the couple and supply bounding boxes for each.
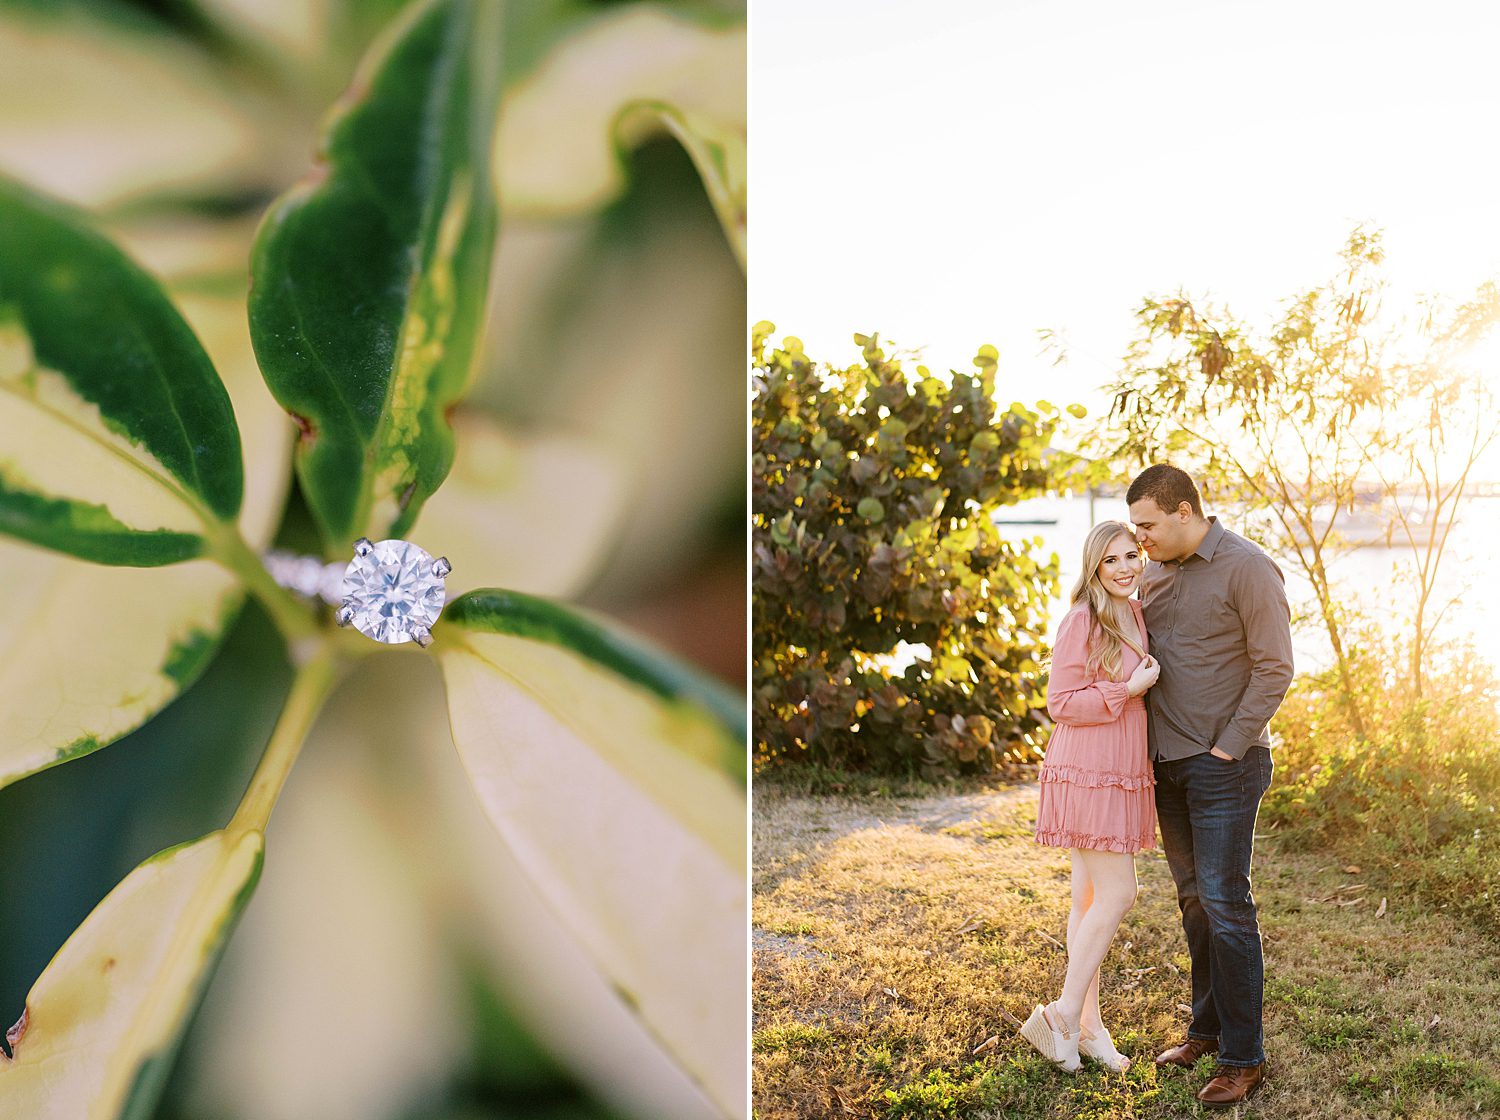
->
[752,324,1058,771]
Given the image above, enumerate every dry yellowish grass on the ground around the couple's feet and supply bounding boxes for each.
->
[755,786,1500,1120]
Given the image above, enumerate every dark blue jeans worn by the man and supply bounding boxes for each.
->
[1155,747,1271,1066]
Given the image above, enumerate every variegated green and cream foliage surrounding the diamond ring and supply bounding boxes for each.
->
[0,0,746,1120]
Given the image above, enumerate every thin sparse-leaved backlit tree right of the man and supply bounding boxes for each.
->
[1092,228,1500,738]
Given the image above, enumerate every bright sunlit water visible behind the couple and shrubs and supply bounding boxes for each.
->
[998,496,1500,670]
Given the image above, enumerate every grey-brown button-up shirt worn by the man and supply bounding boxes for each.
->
[1142,517,1292,762]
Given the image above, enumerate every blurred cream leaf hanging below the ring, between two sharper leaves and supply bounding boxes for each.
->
[171,683,471,1120]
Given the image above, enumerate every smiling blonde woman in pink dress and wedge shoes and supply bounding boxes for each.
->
[1022,522,1161,1074]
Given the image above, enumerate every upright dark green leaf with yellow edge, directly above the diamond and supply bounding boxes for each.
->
[251,0,500,552]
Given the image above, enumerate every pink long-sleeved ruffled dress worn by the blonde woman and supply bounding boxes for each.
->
[1037,600,1157,852]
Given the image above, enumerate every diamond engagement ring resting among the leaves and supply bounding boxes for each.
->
[266,537,453,646]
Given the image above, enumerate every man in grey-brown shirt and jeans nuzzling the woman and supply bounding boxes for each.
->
[1125,463,1292,1107]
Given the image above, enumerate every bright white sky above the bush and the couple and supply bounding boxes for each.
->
[750,0,1500,455]
